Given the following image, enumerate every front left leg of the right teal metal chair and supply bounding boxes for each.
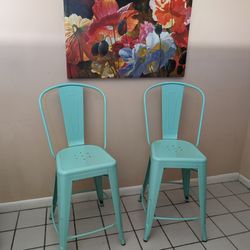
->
[143,161,163,241]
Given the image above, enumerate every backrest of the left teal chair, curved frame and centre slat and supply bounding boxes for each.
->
[39,83,107,157]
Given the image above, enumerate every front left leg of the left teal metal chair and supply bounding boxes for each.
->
[57,176,72,250]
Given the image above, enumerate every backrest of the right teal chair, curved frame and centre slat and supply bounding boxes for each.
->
[144,82,205,146]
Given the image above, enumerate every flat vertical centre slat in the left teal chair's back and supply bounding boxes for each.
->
[58,86,84,146]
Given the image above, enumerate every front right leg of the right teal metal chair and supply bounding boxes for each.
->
[198,165,207,241]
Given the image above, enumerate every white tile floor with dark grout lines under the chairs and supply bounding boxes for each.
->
[0,182,250,250]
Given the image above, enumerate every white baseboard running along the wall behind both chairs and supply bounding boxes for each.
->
[0,173,245,213]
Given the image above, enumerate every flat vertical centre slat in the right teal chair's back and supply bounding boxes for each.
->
[162,84,184,139]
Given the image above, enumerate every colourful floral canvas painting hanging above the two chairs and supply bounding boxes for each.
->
[64,0,192,78]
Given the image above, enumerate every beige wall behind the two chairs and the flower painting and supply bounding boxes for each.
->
[0,0,250,202]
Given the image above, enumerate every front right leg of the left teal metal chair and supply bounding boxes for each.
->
[109,166,126,246]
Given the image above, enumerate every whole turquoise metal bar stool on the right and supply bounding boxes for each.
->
[140,82,207,241]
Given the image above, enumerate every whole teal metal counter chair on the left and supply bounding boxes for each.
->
[39,83,125,250]
